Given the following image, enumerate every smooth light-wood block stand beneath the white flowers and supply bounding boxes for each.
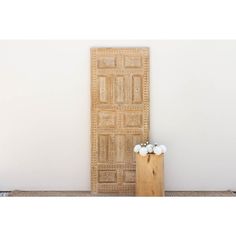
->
[136,154,165,196]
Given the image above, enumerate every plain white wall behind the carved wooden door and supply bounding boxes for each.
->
[0,41,236,190]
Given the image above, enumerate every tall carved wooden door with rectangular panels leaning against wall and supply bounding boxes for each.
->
[91,48,149,195]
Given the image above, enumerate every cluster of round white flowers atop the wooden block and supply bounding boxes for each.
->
[134,142,167,156]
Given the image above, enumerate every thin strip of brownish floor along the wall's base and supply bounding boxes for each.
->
[5,191,236,197]
